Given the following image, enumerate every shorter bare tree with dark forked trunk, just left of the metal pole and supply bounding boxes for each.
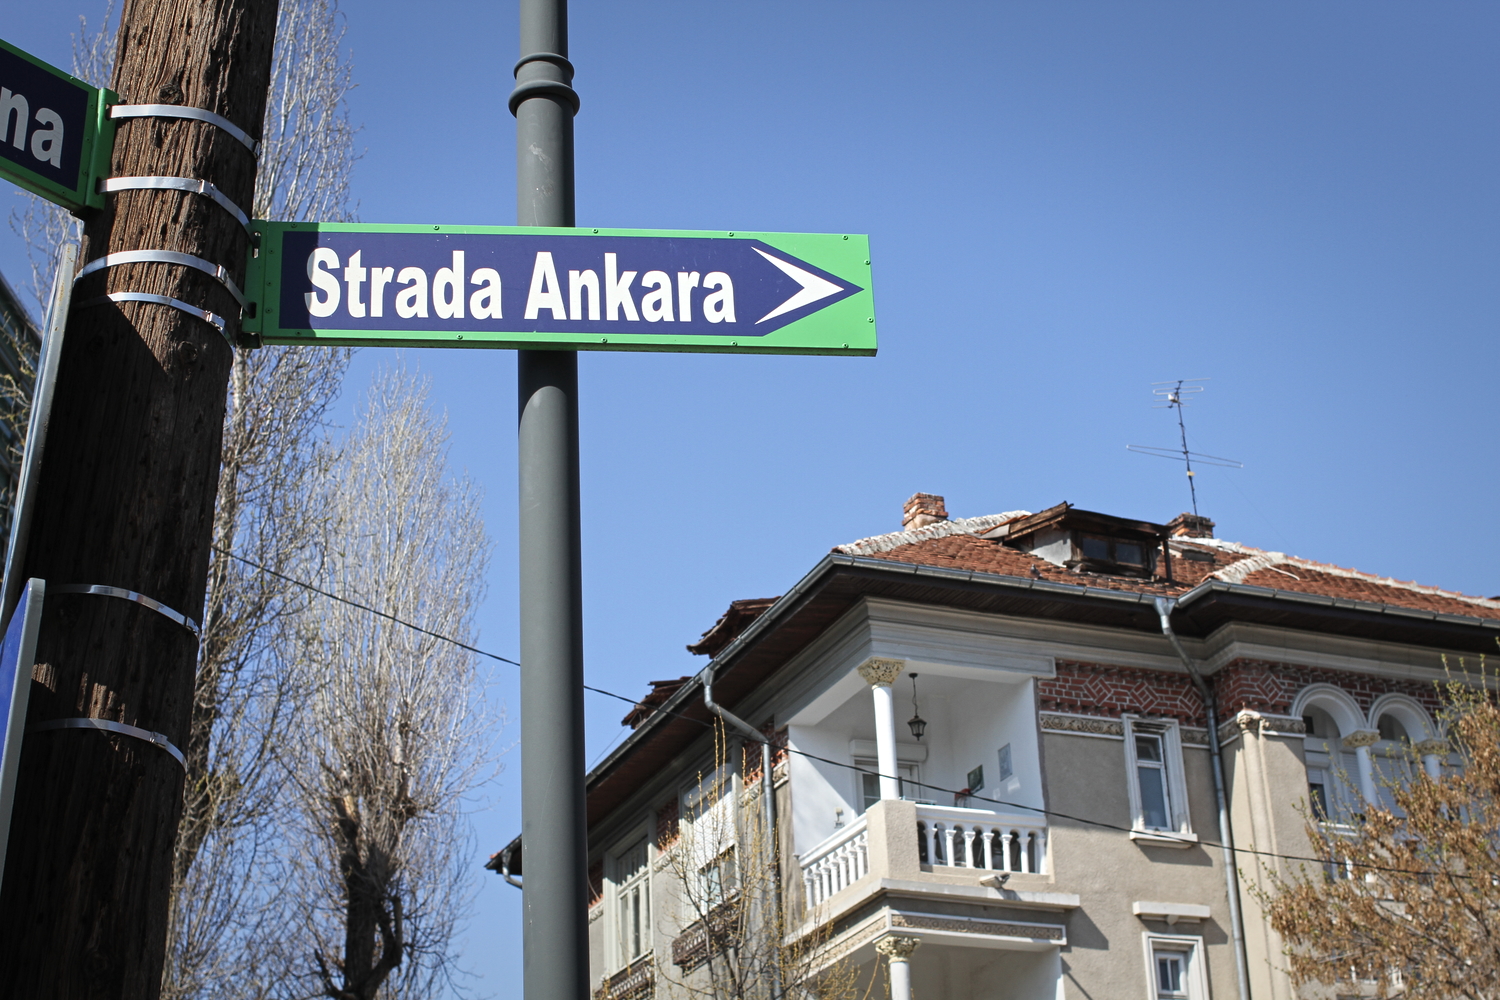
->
[288,369,494,1000]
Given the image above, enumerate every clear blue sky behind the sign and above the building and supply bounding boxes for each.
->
[0,0,1500,997]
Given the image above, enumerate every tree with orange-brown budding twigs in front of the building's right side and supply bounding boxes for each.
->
[1262,671,1500,1000]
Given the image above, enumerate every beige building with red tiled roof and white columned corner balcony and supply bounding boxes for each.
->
[497,495,1500,1000]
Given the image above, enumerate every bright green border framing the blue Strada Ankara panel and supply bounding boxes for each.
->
[240,220,876,357]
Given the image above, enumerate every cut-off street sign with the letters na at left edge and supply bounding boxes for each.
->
[0,40,119,211]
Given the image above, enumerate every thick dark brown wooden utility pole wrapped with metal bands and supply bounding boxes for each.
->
[0,0,276,1000]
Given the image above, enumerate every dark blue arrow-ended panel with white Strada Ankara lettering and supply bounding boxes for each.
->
[281,232,864,337]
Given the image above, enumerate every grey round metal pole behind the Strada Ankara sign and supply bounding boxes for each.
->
[510,0,588,1000]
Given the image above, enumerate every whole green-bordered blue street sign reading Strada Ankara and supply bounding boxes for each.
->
[242,222,876,355]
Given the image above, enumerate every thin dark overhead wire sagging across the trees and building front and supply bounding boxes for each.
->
[213,546,1478,879]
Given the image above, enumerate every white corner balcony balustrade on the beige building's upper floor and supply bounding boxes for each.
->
[798,799,1052,912]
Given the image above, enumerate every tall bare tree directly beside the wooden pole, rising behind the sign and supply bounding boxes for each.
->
[162,0,356,999]
